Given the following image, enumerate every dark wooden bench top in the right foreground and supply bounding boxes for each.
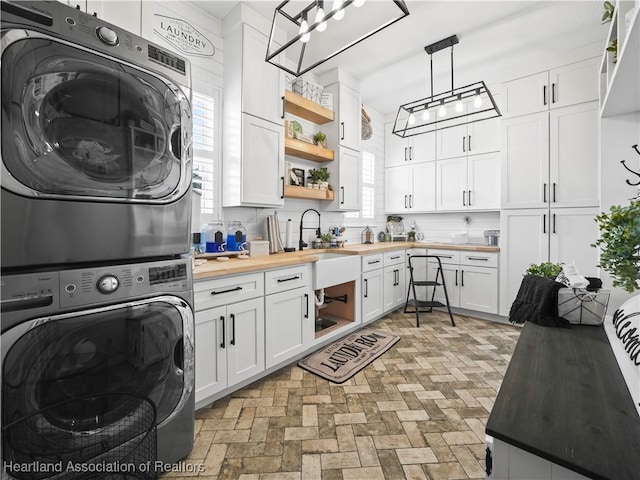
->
[486,323,640,480]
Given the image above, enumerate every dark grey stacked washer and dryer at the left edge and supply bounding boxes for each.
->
[0,0,194,478]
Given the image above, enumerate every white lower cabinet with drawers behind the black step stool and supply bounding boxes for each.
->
[428,249,498,314]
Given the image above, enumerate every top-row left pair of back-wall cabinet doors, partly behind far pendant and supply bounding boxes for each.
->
[385,122,436,167]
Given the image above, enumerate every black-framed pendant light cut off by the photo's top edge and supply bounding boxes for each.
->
[265,0,409,77]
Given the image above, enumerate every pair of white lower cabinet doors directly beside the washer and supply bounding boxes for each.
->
[195,297,265,403]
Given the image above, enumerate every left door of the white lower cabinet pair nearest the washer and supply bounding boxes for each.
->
[195,307,228,403]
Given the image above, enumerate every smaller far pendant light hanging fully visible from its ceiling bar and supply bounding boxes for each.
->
[393,35,502,138]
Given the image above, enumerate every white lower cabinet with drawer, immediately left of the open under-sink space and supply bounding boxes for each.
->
[265,264,315,368]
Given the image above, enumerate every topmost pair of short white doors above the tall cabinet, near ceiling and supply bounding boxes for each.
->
[502,58,599,117]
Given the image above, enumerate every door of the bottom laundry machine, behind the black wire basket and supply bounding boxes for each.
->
[2,296,194,431]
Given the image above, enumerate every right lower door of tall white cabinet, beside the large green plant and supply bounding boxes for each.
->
[549,208,599,277]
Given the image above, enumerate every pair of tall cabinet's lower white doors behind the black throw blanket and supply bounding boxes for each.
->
[500,208,599,316]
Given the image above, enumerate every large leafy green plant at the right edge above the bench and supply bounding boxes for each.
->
[592,200,640,292]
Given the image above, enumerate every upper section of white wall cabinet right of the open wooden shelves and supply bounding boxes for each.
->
[324,82,362,151]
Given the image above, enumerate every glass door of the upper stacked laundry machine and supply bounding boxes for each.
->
[1,30,191,203]
